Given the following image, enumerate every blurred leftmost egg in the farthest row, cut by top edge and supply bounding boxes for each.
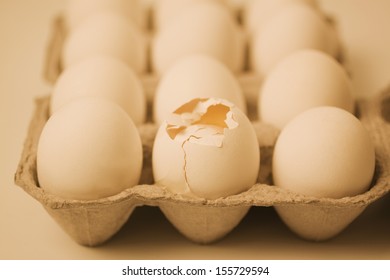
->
[65,0,146,30]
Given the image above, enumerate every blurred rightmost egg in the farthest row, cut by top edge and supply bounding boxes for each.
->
[243,0,317,34]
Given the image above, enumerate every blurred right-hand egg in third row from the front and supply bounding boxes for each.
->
[250,4,338,76]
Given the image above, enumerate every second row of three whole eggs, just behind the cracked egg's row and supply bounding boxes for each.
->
[51,49,355,129]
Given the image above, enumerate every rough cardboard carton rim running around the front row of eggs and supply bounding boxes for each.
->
[15,93,390,209]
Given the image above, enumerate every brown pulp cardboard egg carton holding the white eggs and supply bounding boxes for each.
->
[15,10,390,246]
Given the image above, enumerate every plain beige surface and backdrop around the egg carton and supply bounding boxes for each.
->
[0,0,390,259]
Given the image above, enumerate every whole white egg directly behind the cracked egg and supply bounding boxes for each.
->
[153,54,246,124]
